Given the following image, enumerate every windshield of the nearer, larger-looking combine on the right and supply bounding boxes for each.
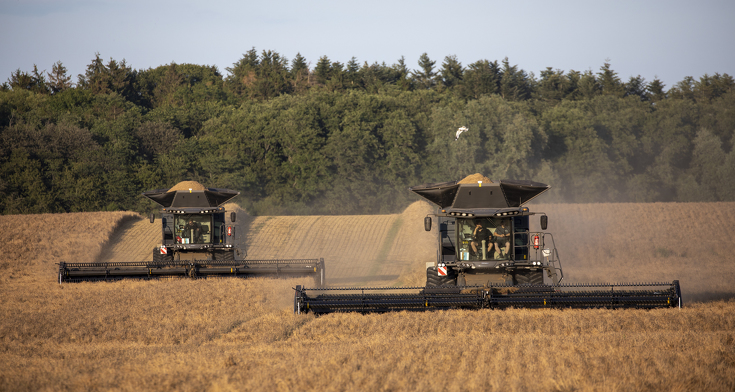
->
[457,217,511,260]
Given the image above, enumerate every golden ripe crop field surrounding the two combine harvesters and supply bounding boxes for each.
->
[0,202,735,391]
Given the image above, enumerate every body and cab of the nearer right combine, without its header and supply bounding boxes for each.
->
[409,175,563,286]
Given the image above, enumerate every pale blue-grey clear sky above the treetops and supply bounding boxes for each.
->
[0,0,735,89]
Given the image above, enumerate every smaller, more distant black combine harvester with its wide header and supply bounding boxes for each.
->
[59,181,325,287]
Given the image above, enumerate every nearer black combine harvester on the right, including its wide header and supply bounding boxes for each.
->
[294,174,682,314]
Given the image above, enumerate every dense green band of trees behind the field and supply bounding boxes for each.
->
[0,49,735,214]
